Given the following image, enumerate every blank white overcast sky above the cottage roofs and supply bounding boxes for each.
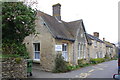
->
[25,0,119,43]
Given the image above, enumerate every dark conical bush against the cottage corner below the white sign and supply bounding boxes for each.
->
[53,54,70,73]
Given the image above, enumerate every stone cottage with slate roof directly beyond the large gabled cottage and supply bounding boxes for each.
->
[87,32,106,58]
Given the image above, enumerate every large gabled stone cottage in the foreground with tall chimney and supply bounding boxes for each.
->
[24,3,88,70]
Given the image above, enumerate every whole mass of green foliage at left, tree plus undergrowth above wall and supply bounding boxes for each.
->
[2,2,36,56]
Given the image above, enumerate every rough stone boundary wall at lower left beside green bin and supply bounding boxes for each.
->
[2,58,27,78]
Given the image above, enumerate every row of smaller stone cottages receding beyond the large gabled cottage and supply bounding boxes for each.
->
[87,32,116,58]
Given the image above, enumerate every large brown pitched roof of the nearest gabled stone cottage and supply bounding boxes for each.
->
[38,11,82,41]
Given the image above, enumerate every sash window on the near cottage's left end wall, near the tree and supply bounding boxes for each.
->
[33,43,40,60]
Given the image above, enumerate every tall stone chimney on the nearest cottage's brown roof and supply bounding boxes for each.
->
[52,3,61,21]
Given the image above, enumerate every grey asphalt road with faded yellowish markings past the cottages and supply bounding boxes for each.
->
[31,60,117,78]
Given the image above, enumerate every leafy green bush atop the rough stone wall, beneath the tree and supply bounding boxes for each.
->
[2,43,29,58]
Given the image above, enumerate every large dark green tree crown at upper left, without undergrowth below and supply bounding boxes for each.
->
[2,2,35,42]
